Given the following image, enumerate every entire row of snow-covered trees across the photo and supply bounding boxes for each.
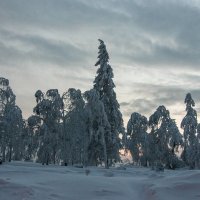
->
[0,39,200,169]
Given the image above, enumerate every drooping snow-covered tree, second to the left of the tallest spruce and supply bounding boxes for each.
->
[61,88,85,165]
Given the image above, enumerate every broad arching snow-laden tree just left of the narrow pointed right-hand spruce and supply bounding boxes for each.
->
[149,106,182,169]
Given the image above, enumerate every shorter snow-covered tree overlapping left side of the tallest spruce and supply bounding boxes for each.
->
[84,89,112,168]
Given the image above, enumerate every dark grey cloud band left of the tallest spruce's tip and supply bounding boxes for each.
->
[0,30,88,66]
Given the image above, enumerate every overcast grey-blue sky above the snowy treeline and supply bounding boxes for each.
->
[0,0,200,126]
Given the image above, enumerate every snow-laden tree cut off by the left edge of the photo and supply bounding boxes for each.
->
[0,77,24,161]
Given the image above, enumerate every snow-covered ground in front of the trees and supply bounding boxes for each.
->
[0,162,200,200]
